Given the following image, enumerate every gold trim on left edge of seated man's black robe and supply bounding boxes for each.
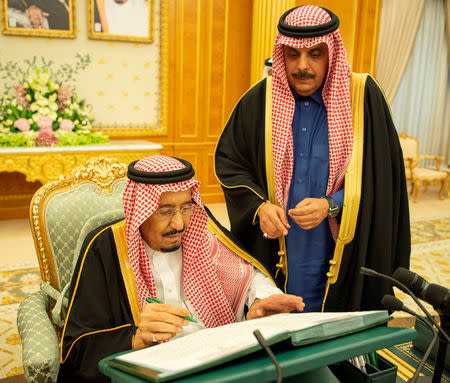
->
[111,220,140,326]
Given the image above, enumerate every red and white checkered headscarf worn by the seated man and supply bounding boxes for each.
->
[123,155,252,327]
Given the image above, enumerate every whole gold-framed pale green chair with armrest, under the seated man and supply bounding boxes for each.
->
[17,157,127,382]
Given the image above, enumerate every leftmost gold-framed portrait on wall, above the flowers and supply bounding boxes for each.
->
[1,0,75,38]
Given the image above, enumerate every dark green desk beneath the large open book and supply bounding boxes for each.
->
[99,327,416,383]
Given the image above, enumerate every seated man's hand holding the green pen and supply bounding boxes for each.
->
[132,303,190,349]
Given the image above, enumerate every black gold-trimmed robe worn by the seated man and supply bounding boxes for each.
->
[58,210,270,383]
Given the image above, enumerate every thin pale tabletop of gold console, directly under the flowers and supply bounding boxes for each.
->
[0,140,162,155]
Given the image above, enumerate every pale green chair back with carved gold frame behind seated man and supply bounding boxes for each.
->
[30,157,127,291]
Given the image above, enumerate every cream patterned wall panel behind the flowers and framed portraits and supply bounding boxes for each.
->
[0,0,161,128]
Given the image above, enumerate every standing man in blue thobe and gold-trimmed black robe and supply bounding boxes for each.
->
[215,6,410,311]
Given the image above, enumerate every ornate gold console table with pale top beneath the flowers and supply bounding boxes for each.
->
[0,140,162,184]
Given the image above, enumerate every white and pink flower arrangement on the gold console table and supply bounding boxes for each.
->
[0,54,109,147]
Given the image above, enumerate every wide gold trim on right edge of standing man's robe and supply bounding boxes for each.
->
[322,73,368,310]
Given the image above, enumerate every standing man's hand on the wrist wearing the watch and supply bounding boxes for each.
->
[288,198,330,230]
